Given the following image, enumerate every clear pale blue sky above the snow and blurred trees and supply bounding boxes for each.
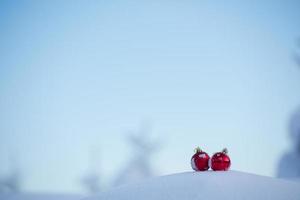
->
[0,1,300,192]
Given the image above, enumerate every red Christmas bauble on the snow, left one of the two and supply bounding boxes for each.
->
[191,147,210,171]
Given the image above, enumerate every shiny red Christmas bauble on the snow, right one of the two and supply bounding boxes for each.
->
[210,148,231,171]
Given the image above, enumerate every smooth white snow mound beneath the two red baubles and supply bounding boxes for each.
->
[85,171,300,200]
